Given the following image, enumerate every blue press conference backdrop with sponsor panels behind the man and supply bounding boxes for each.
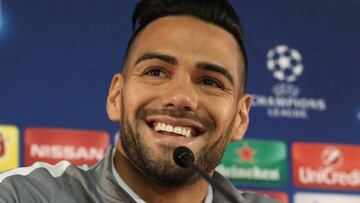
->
[0,0,360,203]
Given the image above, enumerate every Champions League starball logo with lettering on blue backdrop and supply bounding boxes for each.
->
[252,45,327,119]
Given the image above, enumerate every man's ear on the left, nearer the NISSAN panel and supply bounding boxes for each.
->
[106,73,124,121]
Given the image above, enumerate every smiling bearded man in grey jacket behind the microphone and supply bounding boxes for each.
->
[0,0,280,203]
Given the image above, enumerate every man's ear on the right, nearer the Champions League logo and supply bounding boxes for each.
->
[231,94,251,141]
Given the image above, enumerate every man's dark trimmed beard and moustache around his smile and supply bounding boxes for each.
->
[120,108,234,187]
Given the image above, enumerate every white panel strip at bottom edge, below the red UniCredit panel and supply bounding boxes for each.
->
[294,192,360,203]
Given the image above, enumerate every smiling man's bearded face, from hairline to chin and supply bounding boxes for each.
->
[108,17,250,185]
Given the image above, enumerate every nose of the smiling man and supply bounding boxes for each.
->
[162,73,198,111]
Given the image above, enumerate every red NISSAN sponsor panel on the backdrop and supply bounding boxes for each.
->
[25,128,110,165]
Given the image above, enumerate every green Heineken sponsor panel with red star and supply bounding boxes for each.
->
[216,139,287,185]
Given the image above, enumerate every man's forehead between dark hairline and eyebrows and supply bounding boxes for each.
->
[128,16,244,84]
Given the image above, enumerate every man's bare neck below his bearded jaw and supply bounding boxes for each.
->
[115,146,208,203]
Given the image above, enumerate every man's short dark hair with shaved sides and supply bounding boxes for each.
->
[123,0,248,89]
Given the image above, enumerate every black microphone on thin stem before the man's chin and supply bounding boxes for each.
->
[173,146,241,203]
